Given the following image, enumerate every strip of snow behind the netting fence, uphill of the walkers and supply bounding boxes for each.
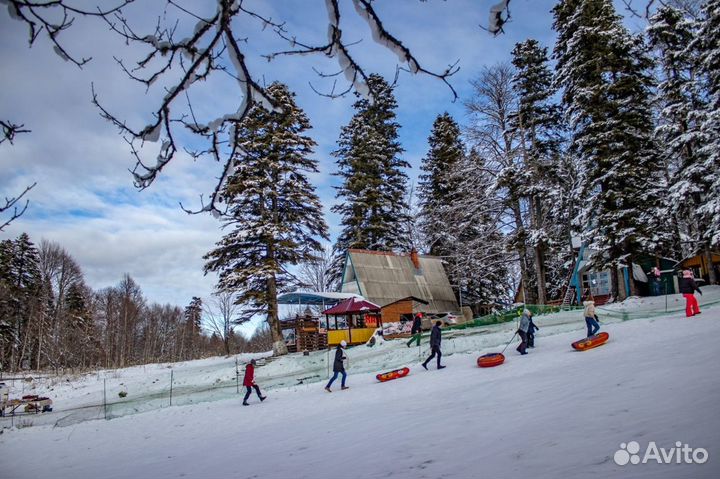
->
[0,286,720,427]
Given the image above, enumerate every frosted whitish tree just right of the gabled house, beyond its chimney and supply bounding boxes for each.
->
[435,149,513,305]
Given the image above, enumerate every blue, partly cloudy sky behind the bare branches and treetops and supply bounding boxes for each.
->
[0,0,640,322]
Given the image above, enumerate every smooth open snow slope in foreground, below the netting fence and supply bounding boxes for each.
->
[0,294,720,479]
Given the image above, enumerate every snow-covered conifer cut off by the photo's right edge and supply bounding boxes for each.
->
[696,0,720,262]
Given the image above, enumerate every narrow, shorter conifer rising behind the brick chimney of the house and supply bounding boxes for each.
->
[418,112,465,262]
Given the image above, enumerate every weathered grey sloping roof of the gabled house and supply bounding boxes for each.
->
[342,249,460,313]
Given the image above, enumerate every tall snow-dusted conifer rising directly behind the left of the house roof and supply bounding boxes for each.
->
[332,74,411,279]
